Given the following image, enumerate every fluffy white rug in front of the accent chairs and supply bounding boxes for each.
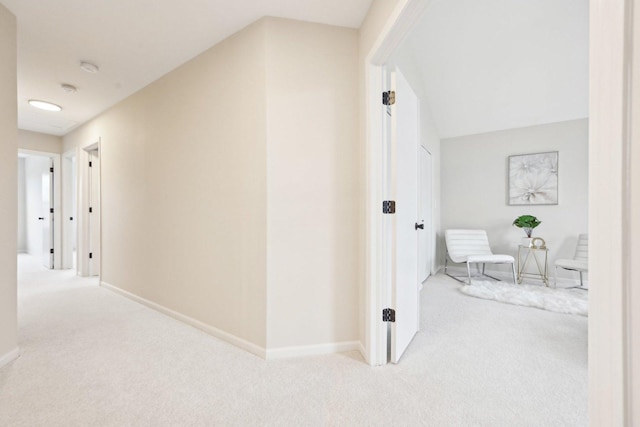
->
[460,281,589,316]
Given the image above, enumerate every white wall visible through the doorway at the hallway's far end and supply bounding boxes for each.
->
[24,156,51,257]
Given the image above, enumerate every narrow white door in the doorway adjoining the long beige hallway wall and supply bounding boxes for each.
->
[89,150,100,276]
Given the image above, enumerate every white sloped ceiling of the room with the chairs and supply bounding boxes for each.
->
[406,0,589,138]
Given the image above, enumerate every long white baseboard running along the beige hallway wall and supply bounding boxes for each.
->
[100,282,267,359]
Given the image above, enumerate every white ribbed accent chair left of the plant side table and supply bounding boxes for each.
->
[444,230,517,285]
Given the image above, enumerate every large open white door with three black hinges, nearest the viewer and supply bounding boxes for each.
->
[390,70,420,363]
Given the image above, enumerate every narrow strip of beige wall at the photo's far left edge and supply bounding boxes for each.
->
[0,4,18,366]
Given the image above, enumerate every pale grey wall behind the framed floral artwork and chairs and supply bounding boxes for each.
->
[440,119,588,278]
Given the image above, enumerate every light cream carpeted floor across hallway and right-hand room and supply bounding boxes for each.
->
[0,256,587,426]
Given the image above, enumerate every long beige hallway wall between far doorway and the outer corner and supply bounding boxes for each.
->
[63,18,266,349]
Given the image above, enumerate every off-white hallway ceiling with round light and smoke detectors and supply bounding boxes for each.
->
[0,0,372,135]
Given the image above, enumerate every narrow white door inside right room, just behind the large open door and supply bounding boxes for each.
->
[418,146,433,283]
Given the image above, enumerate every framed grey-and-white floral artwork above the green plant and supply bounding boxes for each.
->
[507,151,558,206]
